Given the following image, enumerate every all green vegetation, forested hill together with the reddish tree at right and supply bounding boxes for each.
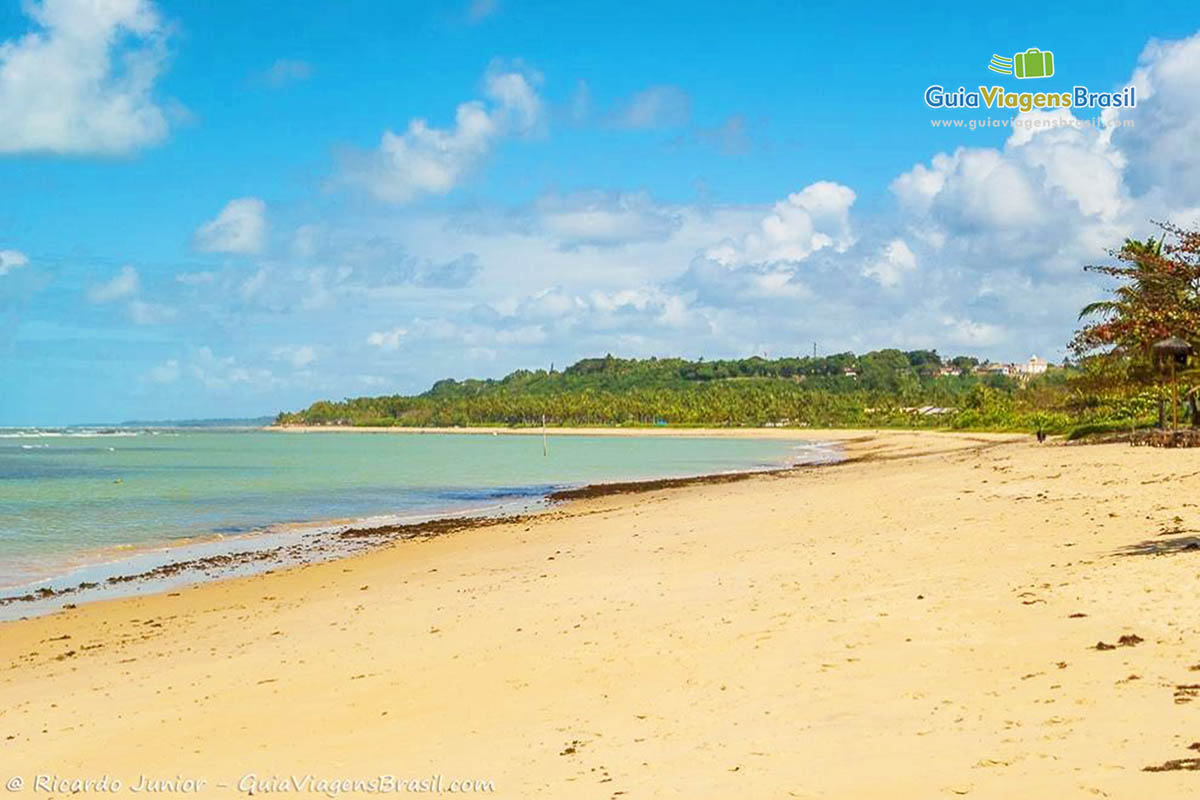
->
[276,224,1200,439]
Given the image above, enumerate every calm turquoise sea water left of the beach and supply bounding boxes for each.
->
[0,429,812,599]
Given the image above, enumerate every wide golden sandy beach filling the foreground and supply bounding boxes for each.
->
[0,431,1200,799]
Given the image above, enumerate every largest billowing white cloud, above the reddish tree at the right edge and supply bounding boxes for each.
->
[863,36,1200,355]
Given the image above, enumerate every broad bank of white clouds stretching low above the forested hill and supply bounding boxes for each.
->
[110,28,1200,402]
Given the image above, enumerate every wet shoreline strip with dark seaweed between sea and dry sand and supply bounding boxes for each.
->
[0,429,841,625]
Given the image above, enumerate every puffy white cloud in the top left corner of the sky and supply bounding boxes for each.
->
[0,0,168,154]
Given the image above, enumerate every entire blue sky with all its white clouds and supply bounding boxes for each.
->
[0,0,1200,426]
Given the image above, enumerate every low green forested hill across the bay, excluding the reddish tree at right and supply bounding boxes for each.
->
[276,350,1068,428]
